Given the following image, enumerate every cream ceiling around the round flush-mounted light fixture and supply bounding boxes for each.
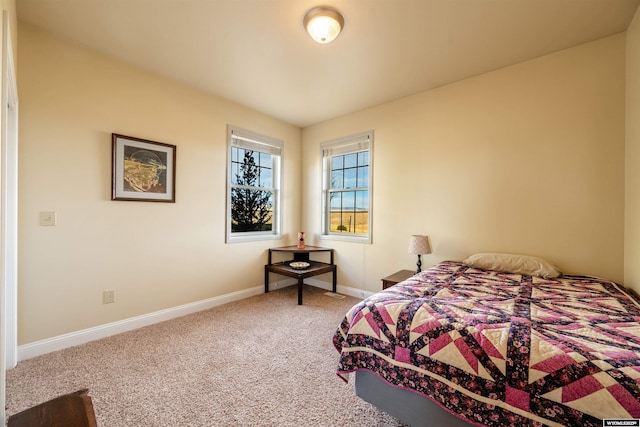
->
[17,0,640,127]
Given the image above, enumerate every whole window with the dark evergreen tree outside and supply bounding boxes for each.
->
[227,126,283,243]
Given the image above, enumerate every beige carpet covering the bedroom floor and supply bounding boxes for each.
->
[6,286,402,427]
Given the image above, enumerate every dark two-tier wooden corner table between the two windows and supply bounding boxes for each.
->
[264,246,337,305]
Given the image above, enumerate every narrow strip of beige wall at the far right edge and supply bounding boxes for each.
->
[624,10,640,292]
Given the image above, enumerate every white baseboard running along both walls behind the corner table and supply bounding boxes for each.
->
[18,279,373,361]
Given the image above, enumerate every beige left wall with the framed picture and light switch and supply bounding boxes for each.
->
[18,23,301,344]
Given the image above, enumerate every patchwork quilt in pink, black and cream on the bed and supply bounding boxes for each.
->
[333,262,640,426]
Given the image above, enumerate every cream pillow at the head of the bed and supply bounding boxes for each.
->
[462,253,562,279]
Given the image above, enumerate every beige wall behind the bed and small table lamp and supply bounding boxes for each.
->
[302,34,625,291]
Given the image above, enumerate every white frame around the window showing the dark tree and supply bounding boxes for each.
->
[225,125,284,243]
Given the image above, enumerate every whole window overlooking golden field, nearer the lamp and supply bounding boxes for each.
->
[321,132,373,243]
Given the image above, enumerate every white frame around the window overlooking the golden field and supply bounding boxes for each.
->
[320,131,373,243]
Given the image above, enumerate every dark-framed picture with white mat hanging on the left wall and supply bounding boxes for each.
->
[111,133,176,203]
